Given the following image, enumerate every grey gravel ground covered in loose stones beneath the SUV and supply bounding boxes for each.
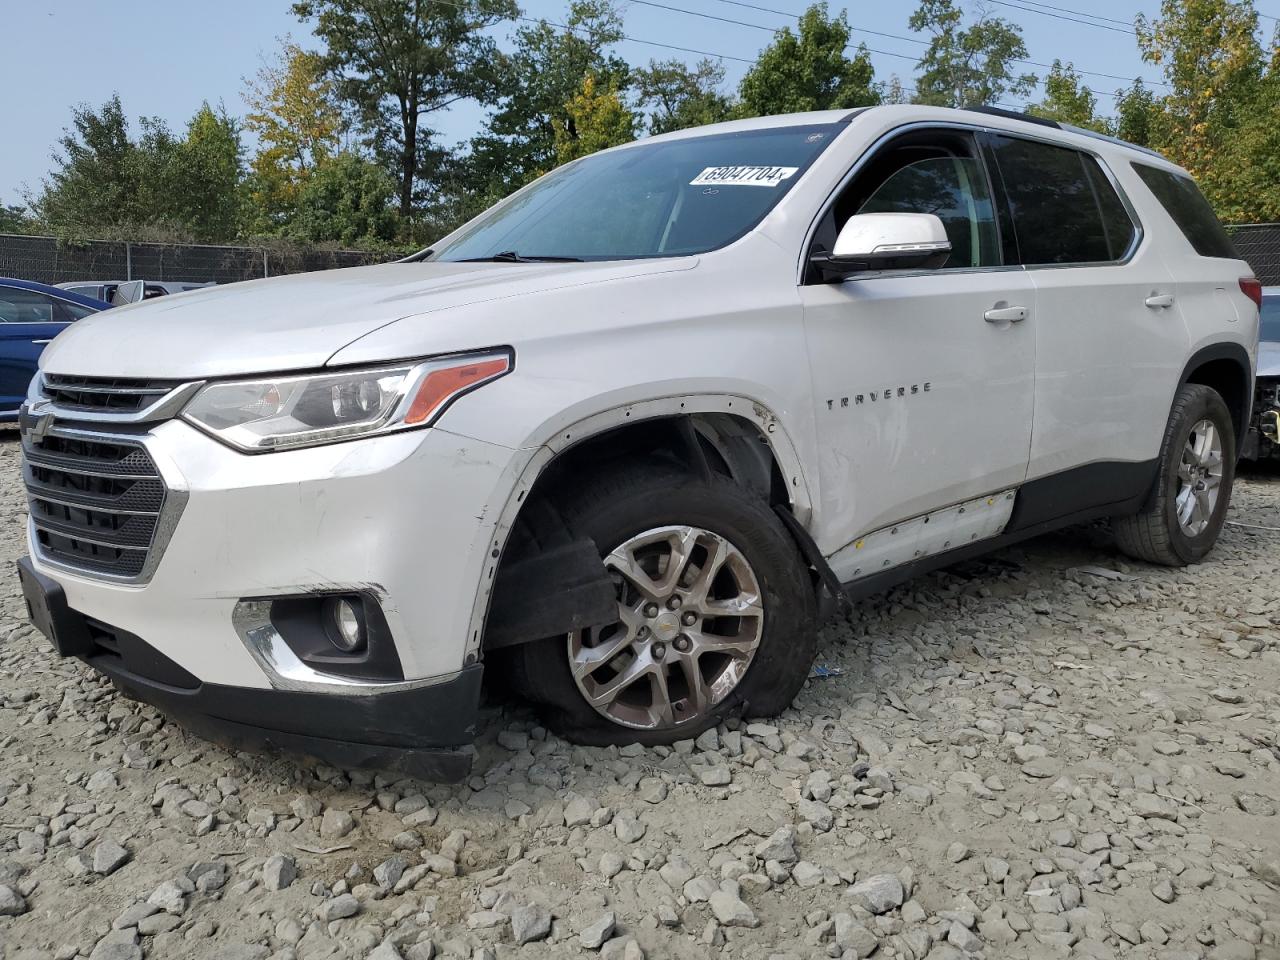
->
[0,439,1280,960]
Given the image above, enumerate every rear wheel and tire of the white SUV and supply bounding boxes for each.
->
[1112,384,1235,567]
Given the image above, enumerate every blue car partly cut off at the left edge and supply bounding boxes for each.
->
[0,276,111,424]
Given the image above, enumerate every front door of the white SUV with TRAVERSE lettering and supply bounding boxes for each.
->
[801,129,1036,580]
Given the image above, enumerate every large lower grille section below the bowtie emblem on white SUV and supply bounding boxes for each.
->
[23,431,169,580]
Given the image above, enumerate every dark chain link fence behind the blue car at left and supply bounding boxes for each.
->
[0,234,401,283]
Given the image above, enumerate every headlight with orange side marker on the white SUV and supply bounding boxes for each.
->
[182,349,515,453]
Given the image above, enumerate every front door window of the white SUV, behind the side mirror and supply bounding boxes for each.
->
[814,131,1002,270]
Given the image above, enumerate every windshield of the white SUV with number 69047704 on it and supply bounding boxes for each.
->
[431,124,844,261]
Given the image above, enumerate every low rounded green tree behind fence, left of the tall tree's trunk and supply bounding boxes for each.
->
[287,152,398,246]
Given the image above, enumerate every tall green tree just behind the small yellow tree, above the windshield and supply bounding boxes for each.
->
[468,0,631,192]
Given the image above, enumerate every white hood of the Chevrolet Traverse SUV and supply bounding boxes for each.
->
[40,260,690,380]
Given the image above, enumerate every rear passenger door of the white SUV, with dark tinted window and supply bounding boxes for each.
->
[987,133,1187,512]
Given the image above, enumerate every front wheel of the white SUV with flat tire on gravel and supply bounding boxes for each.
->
[512,466,817,745]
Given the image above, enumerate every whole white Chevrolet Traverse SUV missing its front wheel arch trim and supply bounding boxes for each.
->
[22,106,1260,778]
